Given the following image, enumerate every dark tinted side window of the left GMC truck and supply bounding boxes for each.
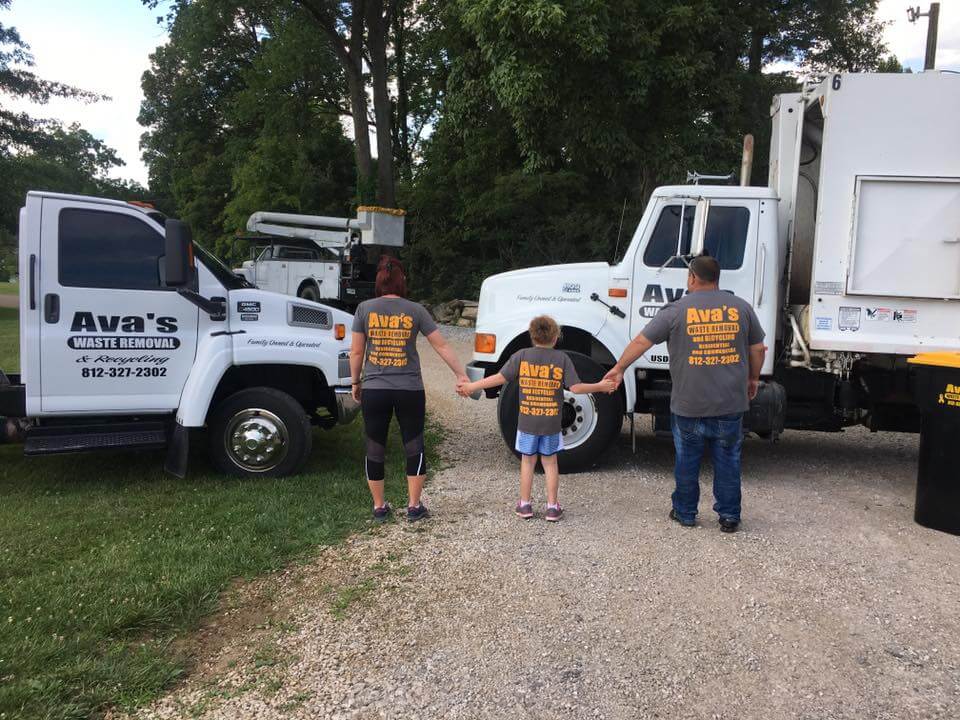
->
[58,208,164,290]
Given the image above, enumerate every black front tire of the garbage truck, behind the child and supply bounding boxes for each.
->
[497,350,623,473]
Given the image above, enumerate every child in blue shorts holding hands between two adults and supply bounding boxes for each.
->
[457,315,616,522]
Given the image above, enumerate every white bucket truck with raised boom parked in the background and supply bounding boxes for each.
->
[233,206,404,308]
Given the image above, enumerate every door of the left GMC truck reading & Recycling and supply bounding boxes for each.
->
[39,198,199,415]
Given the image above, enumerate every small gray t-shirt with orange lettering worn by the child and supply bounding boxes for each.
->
[500,347,580,435]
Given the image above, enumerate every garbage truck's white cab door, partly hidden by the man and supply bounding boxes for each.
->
[630,198,770,369]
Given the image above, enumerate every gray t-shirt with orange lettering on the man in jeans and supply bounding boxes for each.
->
[643,290,764,417]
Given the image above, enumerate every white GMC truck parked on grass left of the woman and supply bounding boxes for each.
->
[0,192,357,476]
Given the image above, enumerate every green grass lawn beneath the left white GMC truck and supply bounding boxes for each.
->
[0,310,435,720]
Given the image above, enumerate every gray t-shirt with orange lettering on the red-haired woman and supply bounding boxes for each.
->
[353,298,437,390]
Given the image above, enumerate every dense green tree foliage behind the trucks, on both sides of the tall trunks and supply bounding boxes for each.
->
[143,0,890,299]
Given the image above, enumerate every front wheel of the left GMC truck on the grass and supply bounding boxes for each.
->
[207,387,313,477]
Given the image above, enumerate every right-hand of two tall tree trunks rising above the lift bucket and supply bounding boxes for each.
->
[366,0,397,207]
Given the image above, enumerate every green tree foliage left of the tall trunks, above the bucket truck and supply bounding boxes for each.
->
[140,0,354,260]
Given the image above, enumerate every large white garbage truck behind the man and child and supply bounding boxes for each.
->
[468,71,960,471]
